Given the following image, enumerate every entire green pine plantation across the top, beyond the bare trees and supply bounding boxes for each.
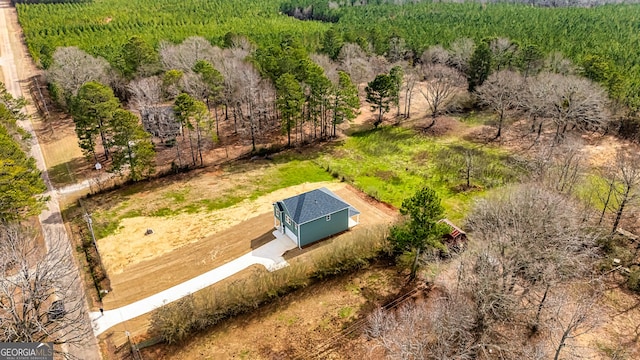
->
[18,0,640,108]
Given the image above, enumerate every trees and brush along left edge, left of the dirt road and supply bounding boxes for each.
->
[0,83,91,356]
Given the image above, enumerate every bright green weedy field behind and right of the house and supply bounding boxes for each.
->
[318,127,519,219]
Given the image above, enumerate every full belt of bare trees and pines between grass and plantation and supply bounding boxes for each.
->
[43,29,610,179]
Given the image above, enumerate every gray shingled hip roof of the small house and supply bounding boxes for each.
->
[281,188,357,224]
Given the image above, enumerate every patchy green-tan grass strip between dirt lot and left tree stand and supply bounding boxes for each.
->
[85,157,333,238]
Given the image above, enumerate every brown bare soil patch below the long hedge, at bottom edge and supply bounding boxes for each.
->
[143,266,406,360]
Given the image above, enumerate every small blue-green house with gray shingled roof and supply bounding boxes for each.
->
[273,188,360,248]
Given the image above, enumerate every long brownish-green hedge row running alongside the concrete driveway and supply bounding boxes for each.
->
[150,226,388,344]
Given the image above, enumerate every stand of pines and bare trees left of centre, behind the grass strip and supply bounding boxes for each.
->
[47,35,360,176]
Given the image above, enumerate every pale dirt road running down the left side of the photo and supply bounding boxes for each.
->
[0,0,101,360]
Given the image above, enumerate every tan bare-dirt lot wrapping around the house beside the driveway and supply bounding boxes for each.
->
[98,182,394,309]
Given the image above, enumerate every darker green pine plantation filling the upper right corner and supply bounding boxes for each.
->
[281,0,640,111]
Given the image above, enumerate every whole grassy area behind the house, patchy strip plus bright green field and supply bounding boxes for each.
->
[81,127,520,237]
